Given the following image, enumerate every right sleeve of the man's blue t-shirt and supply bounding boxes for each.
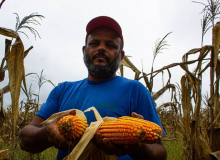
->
[137,88,165,136]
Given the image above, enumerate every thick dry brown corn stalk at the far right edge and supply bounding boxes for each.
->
[209,22,220,152]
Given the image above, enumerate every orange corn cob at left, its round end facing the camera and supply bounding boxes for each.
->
[58,115,88,140]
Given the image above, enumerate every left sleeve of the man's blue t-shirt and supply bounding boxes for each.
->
[36,84,62,119]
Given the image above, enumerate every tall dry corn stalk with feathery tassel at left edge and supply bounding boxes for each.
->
[0,13,43,159]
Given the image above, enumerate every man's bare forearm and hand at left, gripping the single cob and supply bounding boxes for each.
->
[19,110,74,153]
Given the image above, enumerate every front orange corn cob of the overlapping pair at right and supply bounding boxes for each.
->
[98,121,145,145]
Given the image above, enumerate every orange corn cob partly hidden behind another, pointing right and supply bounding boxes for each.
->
[117,116,163,143]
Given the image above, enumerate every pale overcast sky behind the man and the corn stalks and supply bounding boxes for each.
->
[0,0,212,105]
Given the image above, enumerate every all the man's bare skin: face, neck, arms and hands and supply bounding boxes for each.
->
[20,27,166,160]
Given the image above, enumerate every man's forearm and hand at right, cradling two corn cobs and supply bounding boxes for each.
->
[92,112,166,160]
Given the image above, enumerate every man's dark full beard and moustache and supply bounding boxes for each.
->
[83,51,121,79]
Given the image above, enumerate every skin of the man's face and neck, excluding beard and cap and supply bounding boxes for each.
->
[83,27,124,81]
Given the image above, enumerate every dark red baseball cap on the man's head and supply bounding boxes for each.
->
[86,16,124,45]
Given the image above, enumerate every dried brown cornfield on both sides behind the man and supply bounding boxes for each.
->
[0,0,220,160]
